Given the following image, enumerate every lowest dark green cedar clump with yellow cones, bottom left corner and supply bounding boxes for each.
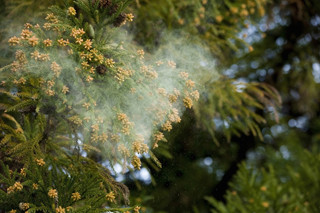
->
[0,159,105,212]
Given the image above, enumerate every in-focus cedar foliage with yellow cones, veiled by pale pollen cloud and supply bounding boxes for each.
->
[0,0,200,212]
